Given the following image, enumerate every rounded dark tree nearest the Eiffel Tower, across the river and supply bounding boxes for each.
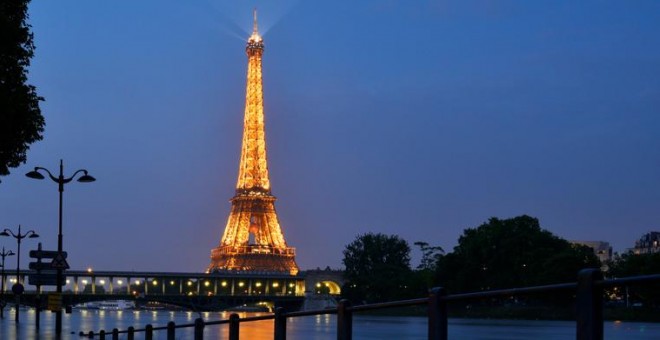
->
[342,233,411,303]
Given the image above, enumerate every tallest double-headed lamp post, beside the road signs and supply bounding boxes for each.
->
[25,159,96,337]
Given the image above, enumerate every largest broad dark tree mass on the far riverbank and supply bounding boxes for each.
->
[437,215,600,292]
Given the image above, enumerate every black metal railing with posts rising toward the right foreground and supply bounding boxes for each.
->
[80,269,660,340]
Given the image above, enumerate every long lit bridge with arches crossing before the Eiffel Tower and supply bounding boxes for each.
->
[2,268,343,310]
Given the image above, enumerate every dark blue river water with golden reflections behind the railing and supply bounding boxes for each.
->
[0,309,660,340]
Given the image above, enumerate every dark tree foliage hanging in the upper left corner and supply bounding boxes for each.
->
[0,0,44,176]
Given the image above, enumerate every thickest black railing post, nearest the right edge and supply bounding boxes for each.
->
[575,269,603,340]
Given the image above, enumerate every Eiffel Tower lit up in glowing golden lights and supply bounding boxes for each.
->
[207,9,298,275]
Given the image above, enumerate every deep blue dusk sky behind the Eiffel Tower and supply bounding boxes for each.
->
[0,0,660,272]
